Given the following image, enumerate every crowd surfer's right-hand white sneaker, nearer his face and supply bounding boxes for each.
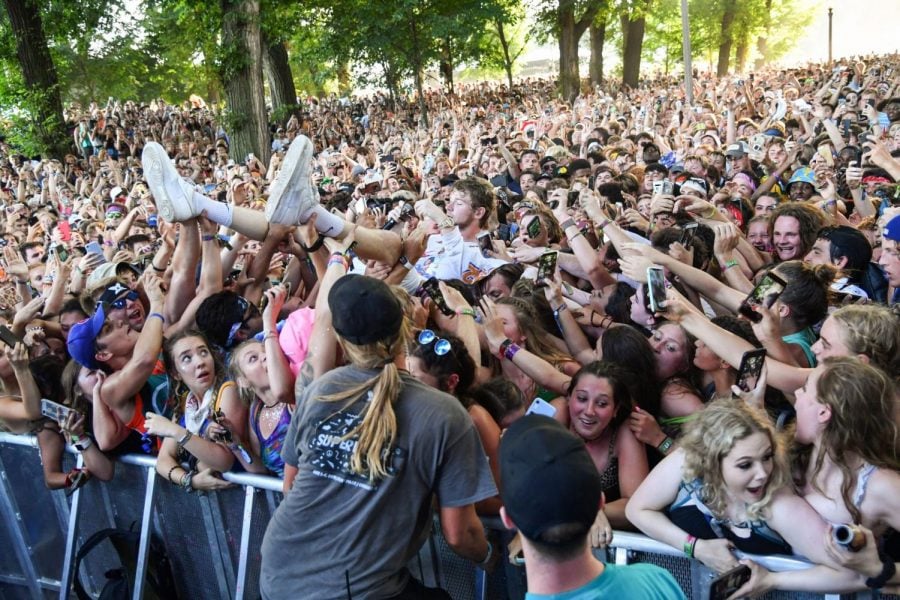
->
[266,135,319,225]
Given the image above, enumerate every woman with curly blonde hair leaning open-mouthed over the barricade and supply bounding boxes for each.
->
[626,400,863,597]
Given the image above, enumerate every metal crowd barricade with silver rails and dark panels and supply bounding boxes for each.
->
[0,433,884,600]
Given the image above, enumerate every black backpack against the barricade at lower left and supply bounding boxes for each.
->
[74,524,178,600]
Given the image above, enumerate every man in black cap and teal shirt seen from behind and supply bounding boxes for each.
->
[500,415,684,600]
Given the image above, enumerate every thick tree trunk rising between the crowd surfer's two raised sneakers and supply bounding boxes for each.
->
[221,0,271,164]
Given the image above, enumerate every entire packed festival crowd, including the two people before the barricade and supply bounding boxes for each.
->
[0,55,900,599]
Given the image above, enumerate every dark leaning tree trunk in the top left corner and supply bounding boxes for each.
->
[4,0,72,159]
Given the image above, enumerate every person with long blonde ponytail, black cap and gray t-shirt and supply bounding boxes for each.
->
[260,274,499,599]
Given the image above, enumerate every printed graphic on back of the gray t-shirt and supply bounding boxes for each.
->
[309,390,406,491]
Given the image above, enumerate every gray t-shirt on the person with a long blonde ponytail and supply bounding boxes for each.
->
[260,366,497,599]
